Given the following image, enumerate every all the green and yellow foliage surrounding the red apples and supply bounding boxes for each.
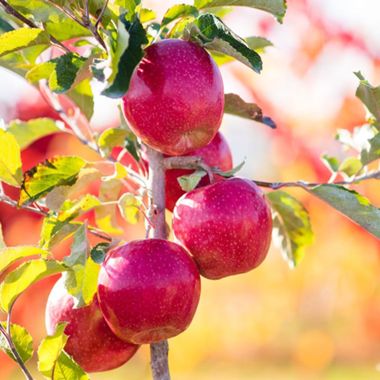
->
[0,0,380,379]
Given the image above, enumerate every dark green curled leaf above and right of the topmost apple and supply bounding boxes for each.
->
[190,13,262,73]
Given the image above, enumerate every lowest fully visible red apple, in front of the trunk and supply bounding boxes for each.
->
[98,239,200,344]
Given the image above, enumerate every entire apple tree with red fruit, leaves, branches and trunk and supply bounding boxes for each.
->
[0,0,380,380]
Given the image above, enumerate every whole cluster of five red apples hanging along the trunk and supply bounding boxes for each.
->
[46,39,272,372]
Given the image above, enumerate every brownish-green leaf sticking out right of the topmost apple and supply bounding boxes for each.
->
[224,94,276,128]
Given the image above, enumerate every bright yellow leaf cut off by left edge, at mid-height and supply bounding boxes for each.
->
[0,129,22,187]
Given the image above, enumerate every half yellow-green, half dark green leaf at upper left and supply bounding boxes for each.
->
[26,53,86,94]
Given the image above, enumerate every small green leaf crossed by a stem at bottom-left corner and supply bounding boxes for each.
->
[0,322,33,363]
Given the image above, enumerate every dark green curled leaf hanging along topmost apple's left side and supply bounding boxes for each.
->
[102,15,148,98]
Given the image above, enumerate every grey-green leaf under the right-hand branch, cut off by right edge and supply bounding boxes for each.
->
[308,185,380,238]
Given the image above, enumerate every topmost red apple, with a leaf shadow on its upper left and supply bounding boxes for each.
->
[123,39,224,156]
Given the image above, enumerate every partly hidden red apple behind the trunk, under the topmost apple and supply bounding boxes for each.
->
[165,132,233,211]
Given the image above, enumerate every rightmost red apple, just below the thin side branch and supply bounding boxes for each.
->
[173,178,272,279]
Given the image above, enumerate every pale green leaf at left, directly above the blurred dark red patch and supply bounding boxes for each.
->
[7,118,60,149]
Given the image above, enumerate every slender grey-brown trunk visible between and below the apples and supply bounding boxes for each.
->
[146,147,170,380]
